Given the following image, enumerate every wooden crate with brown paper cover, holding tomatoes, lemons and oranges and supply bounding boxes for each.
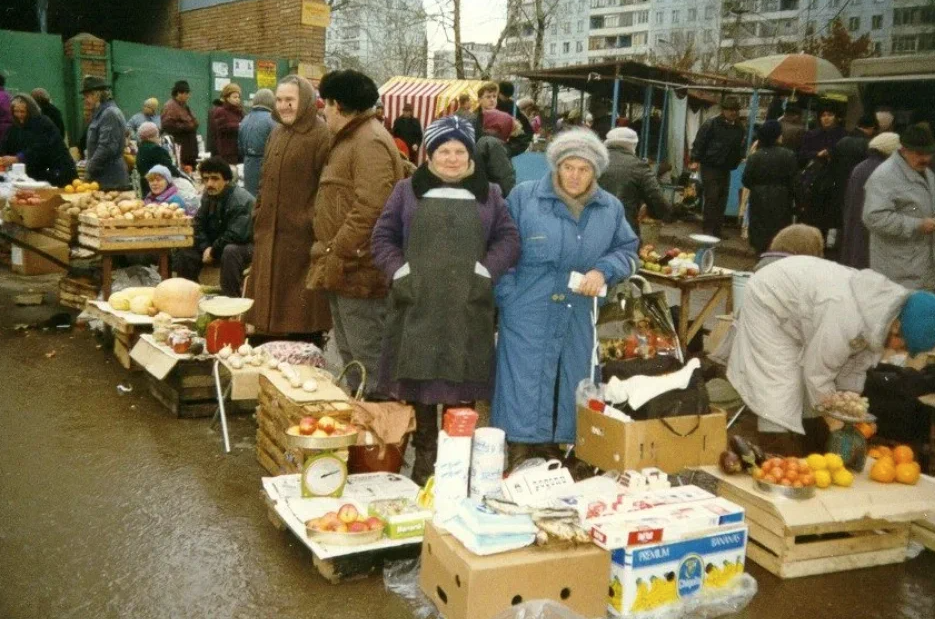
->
[703,467,935,578]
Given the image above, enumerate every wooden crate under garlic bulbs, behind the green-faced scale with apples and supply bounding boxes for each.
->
[256,374,350,475]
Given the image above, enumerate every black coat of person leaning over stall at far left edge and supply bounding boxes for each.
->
[0,115,78,187]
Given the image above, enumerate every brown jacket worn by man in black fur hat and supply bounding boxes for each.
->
[308,112,404,299]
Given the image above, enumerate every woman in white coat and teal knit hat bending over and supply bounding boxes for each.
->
[727,256,935,456]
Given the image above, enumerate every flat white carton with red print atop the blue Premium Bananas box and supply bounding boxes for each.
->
[591,498,744,550]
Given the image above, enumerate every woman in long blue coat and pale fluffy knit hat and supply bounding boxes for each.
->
[491,129,639,465]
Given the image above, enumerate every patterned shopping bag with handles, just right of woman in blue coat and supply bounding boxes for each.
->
[597,276,681,362]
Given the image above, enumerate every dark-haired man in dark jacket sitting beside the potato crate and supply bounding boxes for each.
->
[174,156,255,297]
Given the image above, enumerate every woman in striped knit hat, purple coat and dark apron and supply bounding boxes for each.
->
[372,116,520,485]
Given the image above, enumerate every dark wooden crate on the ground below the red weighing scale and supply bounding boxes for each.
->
[146,359,226,419]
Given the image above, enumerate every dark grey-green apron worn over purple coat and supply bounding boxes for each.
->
[388,198,494,383]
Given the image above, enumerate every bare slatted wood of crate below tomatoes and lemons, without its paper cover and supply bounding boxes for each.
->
[718,481,910,578]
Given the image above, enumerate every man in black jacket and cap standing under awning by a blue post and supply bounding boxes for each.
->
[691,97,746,236]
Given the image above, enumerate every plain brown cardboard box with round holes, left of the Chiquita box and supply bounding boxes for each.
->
[419,524,610,619]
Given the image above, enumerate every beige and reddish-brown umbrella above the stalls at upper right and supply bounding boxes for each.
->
[734,54,854,95]
